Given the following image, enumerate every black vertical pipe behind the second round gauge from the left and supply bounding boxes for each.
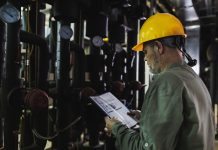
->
[56,22,70,150]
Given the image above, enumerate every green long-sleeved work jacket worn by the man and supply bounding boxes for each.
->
[112,64,215,150]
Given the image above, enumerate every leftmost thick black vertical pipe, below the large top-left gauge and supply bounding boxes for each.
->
[2,22,20,150]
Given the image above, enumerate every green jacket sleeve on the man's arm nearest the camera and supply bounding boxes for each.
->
[112,76,183,150]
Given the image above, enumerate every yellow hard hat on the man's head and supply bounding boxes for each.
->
[132,13,186,51]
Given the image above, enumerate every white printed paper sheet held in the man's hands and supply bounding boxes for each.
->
[90,92,137,128]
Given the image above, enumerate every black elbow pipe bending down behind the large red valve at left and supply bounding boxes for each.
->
[20,30,49,150]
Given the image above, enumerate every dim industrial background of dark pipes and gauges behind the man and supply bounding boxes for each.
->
[0,0,218,150]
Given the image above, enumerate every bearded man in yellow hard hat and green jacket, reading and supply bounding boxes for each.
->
[105,13,215,150]
